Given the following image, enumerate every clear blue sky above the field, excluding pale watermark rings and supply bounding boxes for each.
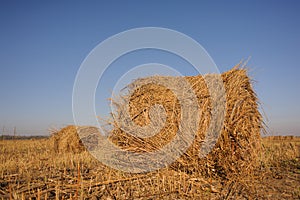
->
[0,0,300,135]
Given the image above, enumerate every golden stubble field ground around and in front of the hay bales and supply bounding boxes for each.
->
[0,137,300,199]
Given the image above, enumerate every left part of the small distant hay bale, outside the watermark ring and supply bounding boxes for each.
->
[50,125,85,153]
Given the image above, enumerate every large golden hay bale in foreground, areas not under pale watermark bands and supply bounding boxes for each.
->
[110,67,263,178]
